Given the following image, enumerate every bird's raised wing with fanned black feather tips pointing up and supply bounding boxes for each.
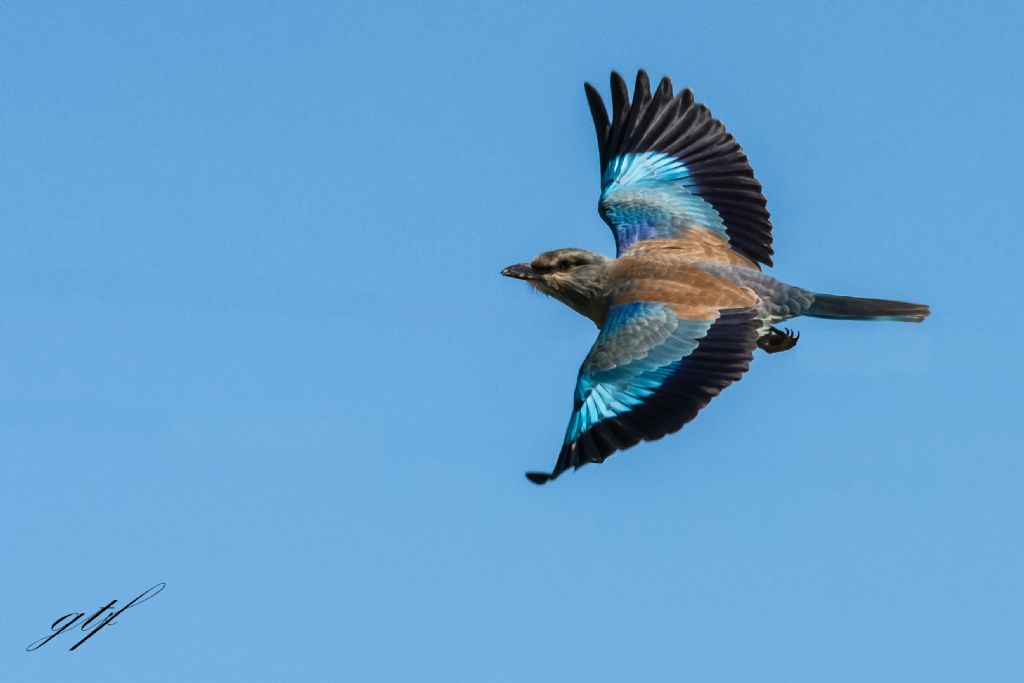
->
[585,71,772,265]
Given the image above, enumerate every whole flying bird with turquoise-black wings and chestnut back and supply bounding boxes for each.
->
[502,71,930,484]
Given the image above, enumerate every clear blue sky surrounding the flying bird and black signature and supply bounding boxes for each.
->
[0,0,1024,682]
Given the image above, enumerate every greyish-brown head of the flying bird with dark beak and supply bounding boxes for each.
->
[502,249,611,327]
